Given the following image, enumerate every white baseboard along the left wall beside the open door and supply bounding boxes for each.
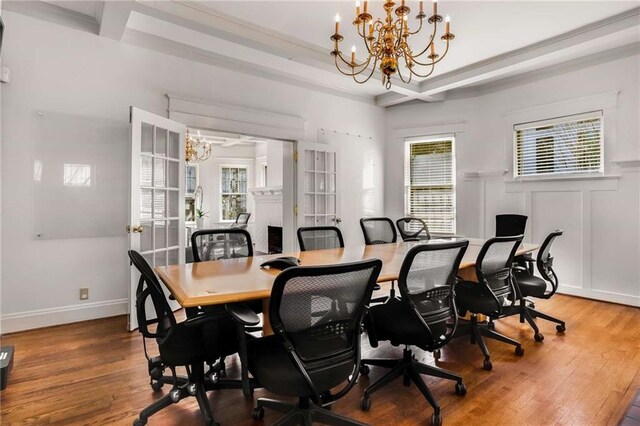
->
[0,299,128,334]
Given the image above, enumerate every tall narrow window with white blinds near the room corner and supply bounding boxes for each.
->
[404,137,456,234]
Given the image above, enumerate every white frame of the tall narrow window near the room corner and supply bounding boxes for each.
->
[403,134,458,235]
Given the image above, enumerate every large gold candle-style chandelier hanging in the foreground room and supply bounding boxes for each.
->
[331,0,455,90]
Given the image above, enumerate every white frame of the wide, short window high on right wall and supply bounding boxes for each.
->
[512,109,605,181]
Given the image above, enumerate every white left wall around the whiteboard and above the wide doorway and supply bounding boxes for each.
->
[1,11,385,332]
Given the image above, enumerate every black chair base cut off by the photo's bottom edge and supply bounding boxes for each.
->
[252,398,366,426]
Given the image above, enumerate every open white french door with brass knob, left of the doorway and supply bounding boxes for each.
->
[127,107,186,330]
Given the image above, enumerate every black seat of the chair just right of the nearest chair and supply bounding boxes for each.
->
[370,299,447,350]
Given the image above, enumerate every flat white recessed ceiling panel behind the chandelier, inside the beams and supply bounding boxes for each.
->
[199,0,640,76]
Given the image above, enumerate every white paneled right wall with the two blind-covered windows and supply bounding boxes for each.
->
[385,54,640,306]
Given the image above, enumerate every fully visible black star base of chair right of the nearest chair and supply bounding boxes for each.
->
[361,346,467,424]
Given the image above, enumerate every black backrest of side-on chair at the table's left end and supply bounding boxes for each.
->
[127,250,176,342]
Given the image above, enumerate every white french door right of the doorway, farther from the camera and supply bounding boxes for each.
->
[297,142,341,247]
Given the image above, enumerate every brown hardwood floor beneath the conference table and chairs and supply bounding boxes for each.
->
[0,295,640,425]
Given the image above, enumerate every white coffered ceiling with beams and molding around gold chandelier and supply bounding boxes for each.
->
[2,0,640,106]
